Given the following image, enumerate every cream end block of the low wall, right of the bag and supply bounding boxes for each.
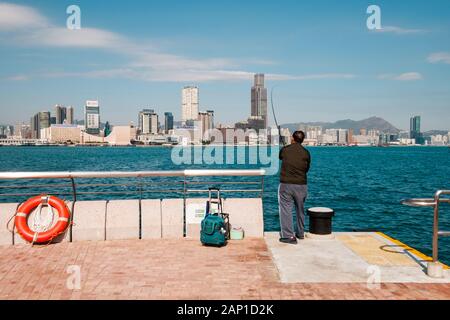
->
[223,198,264,238]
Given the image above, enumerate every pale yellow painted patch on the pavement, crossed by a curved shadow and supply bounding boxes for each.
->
[338,234,417,267]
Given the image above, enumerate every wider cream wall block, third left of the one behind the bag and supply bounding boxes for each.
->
[106,200,140,240]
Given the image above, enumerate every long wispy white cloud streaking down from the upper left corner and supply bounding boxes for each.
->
[0,3,354,82]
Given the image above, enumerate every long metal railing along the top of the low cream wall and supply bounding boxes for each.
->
[0,169,265,201]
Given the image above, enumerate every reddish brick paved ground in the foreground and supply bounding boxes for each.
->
[0,239,450,299]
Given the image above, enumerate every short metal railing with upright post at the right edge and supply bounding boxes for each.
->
[402,190,450,263]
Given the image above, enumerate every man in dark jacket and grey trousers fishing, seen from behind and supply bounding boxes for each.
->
[278,131,311,244]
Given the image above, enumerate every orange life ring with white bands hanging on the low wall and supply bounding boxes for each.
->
[14,195,70,244]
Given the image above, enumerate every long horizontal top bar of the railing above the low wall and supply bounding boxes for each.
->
[0,169,266,180]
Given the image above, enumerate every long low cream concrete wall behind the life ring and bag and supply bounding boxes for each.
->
[0,198,264,245]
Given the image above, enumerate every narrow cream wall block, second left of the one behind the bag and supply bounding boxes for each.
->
[141,200,162,239]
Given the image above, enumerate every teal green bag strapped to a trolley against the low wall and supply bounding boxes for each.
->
[200,214,227,247]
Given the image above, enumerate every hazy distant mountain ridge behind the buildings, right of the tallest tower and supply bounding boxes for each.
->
[281,117,400,134]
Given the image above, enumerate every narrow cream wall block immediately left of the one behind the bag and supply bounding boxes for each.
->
[161,199,184,239]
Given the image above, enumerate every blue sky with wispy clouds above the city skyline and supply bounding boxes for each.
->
[0,0,450,130]
